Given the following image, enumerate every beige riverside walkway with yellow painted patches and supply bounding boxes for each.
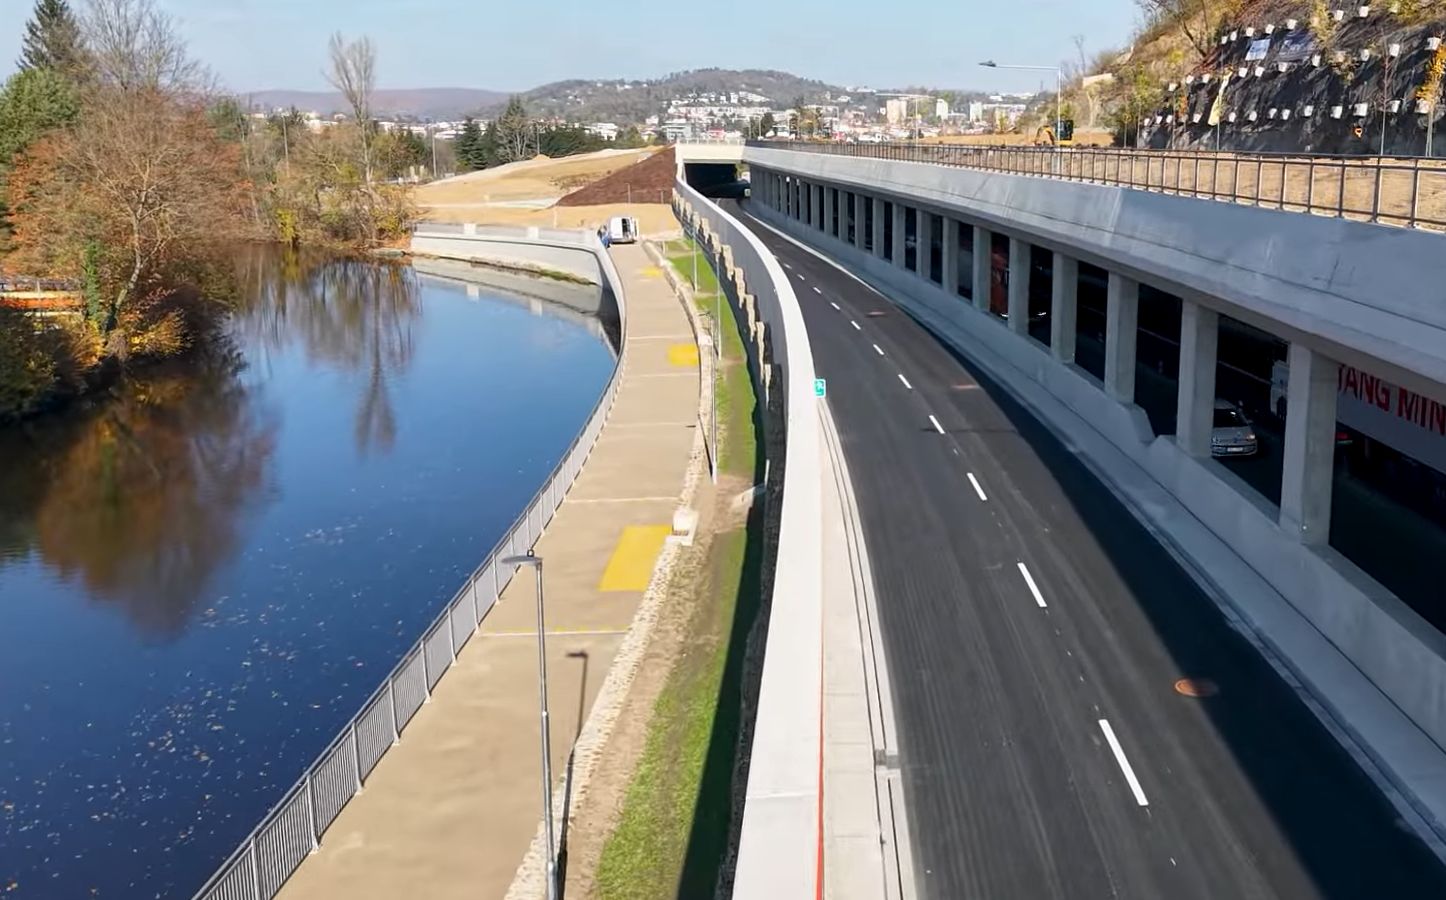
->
[279,246,698,900]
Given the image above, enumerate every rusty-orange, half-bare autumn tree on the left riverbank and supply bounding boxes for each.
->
[10,88,246,341]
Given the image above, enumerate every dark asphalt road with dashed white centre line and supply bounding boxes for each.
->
[733,207,1446,900]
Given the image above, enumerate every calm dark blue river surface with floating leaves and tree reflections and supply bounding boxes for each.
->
[0,252,613,900]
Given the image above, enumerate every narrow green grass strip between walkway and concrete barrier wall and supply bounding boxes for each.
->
[597,238,762,900]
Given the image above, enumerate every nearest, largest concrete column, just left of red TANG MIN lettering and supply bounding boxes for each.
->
[1280,343,1340,545]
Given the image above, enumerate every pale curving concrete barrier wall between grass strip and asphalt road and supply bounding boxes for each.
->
[674,175,823,899]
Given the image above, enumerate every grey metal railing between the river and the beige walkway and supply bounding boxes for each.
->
[195,226,628,900]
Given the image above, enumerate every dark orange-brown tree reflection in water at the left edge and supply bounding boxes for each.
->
[0,353,275,637]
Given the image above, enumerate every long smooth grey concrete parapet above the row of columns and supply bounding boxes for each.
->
[743,148,1446,408]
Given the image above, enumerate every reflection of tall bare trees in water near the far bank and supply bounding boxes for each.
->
[228,249,421,453]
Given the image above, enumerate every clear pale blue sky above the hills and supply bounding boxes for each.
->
[0,0,1135,91]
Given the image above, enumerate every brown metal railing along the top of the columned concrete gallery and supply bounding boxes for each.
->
[748,140,1446,230]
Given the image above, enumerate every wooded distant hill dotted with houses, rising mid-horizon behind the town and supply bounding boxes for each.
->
[484,69,873,123]
